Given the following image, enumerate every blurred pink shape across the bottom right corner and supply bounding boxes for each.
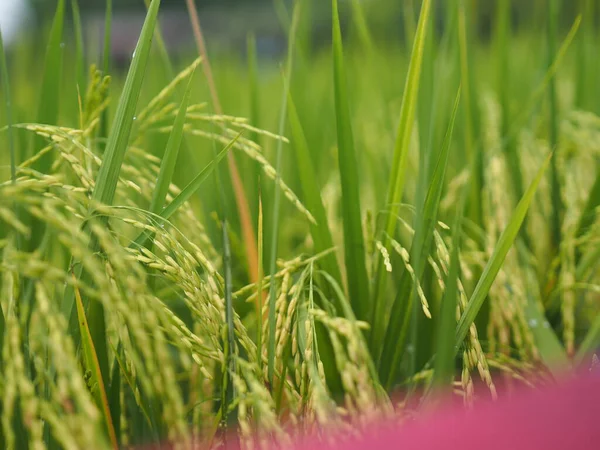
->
[144,371,600,450]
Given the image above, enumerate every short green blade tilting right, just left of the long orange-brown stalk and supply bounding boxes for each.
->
[149,72,194,214]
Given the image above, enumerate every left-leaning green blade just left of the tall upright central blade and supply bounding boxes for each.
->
[288,95,342,284]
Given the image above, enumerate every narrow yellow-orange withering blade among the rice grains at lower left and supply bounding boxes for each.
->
[74,276,118,449]
